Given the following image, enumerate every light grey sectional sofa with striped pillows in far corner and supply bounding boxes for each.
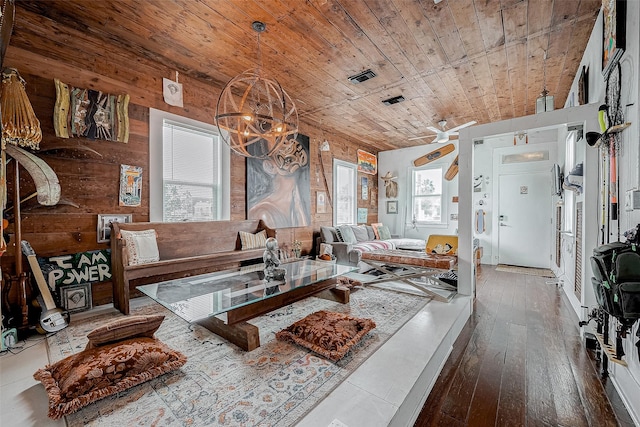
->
[318,224,426,267]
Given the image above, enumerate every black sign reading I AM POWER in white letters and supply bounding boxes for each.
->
[38,249,111,291]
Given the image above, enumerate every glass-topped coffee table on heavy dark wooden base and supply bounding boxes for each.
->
[137,259,357,351]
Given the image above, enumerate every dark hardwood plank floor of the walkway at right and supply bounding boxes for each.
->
[415,266,633,427]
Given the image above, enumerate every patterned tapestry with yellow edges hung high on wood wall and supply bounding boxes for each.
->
[53,79,129,142]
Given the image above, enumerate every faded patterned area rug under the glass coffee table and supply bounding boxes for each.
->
[43,288,429,426]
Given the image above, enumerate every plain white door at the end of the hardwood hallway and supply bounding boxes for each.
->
[498,172,551,268]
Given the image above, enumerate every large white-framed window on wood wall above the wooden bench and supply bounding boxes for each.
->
[149,109,230,222]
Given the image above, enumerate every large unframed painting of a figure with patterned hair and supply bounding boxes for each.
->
[247,134,311,228]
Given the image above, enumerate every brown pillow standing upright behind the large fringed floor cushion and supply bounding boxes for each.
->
[87,314,164,348]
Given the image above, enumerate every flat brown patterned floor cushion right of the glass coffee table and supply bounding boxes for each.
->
[276,310,376,361]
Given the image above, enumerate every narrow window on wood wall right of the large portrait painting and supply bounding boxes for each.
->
[333,160,358,225]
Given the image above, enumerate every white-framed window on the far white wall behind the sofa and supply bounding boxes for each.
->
[409,166,447,224]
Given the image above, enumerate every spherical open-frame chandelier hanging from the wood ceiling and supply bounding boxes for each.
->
[215,21,298,158]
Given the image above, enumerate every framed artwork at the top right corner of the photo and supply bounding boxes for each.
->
[602,0,627,77]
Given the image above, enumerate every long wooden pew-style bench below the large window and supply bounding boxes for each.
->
[111,220,276,314]
